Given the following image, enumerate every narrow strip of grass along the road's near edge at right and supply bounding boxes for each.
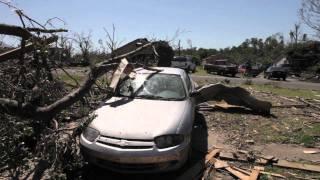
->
[242,84,320,99]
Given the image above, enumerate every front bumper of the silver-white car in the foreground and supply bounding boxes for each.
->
[80,135,190,173]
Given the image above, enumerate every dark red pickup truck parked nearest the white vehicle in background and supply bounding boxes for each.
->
[204,59,238,77]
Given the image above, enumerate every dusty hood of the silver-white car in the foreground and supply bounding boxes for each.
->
[89,97,186,140]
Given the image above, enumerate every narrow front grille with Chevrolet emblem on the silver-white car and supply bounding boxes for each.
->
[97,136,154,149]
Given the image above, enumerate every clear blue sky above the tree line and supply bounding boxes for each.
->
[0,0,310,48]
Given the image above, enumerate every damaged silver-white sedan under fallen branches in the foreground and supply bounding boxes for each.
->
[80,67,197,172]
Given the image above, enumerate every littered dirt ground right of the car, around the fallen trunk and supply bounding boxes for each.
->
[200,87,320,179]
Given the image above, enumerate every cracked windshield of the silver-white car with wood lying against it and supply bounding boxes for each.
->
[118,74,186,100]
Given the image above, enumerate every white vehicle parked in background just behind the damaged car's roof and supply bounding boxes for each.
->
[171,56,196,73]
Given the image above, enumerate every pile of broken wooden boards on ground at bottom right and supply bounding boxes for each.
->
[186,148,320,180]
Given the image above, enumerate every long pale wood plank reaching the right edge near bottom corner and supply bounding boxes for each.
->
[273,160,320,172]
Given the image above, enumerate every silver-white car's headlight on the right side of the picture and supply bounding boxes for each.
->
[154,134,184,149]
